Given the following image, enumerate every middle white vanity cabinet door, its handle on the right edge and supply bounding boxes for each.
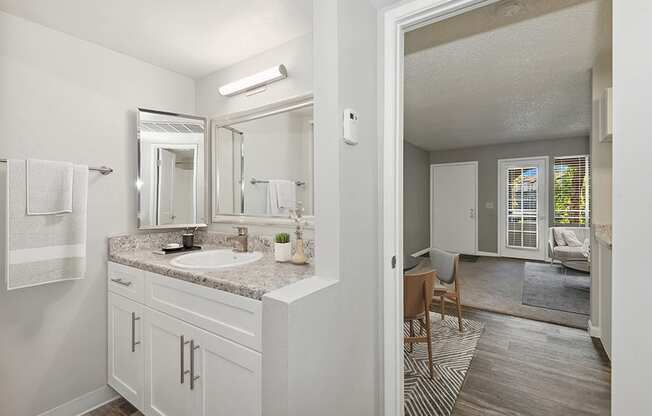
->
[145,308,193,416]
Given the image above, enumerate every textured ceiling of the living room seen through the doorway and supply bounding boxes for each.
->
[404,0,601,150]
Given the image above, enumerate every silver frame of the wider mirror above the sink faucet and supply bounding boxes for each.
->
[210,92,316,229]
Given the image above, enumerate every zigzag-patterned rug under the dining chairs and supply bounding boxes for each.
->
[403,313,484,416]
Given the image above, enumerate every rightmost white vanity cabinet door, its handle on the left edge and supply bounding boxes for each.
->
[193,329,262,416]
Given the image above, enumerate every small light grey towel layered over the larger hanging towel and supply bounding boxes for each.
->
[25,159,73,215]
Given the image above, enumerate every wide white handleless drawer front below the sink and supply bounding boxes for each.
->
[145,272,262,351]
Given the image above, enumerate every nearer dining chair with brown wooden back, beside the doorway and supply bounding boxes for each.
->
[403,270,436,379]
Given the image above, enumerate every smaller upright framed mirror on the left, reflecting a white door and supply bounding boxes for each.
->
[137,109,206,229]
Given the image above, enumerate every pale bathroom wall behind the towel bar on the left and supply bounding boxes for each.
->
[0,13,195,416]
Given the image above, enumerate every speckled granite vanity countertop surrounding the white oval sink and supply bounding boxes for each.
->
[109,244,314,300]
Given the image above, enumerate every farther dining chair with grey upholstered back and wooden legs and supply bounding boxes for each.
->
[430,248,464,332]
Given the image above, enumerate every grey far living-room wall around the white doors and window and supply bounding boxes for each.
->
[430,137,589,253]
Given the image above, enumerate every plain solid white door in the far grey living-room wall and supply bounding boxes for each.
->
[430,162,478,254]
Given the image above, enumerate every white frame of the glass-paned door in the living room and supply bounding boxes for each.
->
[496,156,550,260]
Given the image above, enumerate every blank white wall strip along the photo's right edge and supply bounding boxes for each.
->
[612,0,652,416]
